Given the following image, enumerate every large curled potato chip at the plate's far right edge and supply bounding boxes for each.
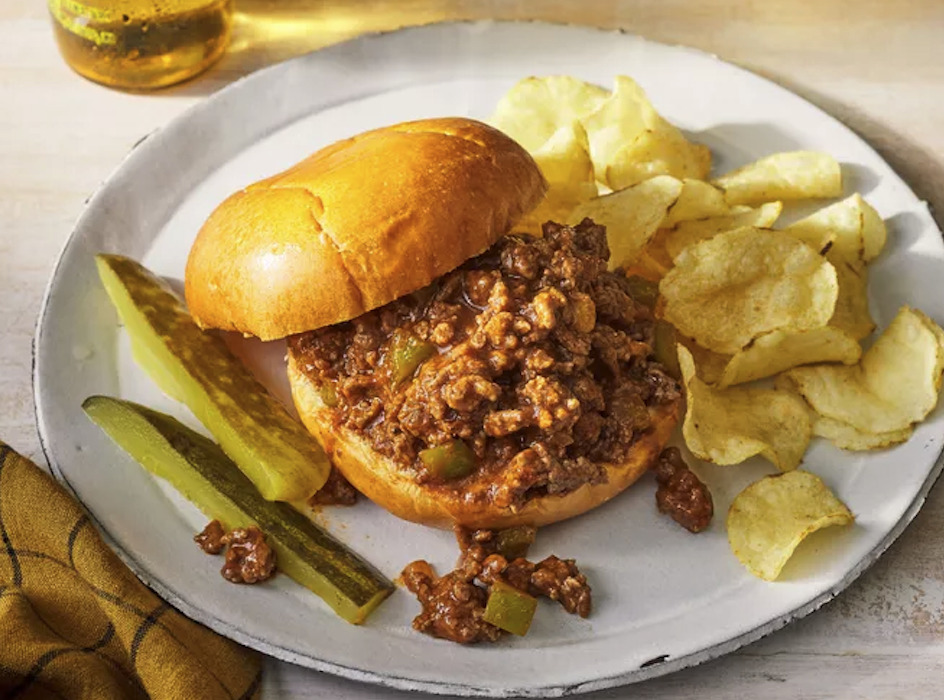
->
[783,306,944,434]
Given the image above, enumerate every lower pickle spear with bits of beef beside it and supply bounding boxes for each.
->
[82,396,393,624]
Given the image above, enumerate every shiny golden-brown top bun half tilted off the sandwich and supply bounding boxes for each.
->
[185,118,547,340]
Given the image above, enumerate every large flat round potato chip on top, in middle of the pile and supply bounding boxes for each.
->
[659,228,839,354]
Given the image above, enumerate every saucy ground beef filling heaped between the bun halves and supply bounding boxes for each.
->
[289,220,679,507]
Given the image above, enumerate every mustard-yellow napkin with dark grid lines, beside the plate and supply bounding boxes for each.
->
[0,442,261,700]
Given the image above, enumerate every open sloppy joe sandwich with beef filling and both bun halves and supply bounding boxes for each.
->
[186,118,681,528]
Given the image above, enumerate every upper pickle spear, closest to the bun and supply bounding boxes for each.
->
[95,255,331,501]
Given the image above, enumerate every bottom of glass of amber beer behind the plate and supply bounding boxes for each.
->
[48,0,233,89]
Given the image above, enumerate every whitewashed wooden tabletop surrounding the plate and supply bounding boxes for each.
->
[0,0,944,700]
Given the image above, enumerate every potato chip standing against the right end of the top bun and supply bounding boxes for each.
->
[515,121,597,236]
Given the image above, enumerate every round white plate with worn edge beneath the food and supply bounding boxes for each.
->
[35,23,944,696]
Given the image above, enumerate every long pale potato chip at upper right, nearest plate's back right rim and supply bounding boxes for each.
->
[712,151,842,204]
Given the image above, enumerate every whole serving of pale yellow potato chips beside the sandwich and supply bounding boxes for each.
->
[491,76,944,580]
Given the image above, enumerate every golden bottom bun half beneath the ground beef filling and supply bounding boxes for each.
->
[288,351,681,528]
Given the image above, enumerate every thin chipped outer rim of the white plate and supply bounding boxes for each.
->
[31,19,944,698]
